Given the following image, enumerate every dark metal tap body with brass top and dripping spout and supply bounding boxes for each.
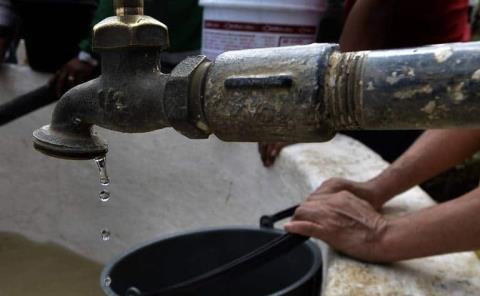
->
[34,0,169,159]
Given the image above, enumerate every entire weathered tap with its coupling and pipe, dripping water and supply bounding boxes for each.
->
[34,0,480,159]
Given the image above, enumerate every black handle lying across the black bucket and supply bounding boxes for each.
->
[124,205,309,296]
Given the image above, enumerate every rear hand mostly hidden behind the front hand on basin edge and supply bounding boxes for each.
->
[307,178,389,210]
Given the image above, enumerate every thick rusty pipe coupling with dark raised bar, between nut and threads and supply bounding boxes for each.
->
[204,44,337,142]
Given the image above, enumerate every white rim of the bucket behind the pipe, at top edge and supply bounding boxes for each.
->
[199,0,327,12]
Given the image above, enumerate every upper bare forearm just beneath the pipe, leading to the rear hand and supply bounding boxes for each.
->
[367,130,480,205]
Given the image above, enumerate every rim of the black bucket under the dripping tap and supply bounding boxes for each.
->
[100,226,323,296]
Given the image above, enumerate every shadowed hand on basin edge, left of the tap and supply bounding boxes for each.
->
[50,58,95,97]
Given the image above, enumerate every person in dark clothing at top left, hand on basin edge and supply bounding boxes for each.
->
[0,0,97,96]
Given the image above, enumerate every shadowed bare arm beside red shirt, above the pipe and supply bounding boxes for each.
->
[340,0,396,51]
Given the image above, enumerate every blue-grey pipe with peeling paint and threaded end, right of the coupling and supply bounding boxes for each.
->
[334,42,480,130]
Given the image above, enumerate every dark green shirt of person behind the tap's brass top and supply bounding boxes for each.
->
[80,0,203,52]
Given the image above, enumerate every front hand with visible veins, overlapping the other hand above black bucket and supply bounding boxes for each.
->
[285,191,388,262]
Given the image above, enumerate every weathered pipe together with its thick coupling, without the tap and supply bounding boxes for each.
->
[204,43,480,142]
